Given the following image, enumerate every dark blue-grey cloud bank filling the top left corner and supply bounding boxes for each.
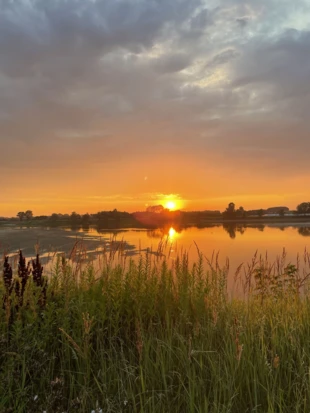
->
[0,0,199,103]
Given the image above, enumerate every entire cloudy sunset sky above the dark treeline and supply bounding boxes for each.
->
[0,0,310,216]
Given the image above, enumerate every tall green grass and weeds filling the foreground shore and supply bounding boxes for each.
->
[0,245,310,413]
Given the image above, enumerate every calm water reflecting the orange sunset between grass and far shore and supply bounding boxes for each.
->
[0,223,310,271]
